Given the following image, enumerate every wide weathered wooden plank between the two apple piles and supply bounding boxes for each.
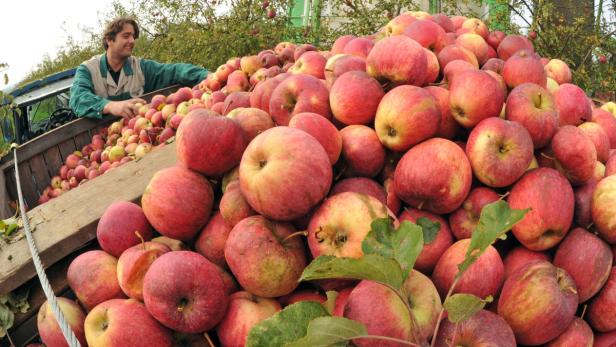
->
[0,143,176,295]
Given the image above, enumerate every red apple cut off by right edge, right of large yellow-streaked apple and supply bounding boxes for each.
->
[588,266,616,333]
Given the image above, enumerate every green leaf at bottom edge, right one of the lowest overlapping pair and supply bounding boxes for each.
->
[285,317,368,347]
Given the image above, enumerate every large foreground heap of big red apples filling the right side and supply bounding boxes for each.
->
[32,12,616,347]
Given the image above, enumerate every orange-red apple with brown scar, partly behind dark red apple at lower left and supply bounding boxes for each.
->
[117,242,171,301]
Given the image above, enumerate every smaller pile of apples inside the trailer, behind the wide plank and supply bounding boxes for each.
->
[38,86,206,204]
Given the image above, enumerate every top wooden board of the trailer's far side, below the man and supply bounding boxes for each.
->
[0,116,117,170]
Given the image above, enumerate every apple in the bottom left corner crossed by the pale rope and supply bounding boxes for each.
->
[36,297,87,347]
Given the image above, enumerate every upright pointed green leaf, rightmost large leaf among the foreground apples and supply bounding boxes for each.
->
[456,200,529,277]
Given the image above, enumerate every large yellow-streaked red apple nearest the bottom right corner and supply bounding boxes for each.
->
[498,260,578,346]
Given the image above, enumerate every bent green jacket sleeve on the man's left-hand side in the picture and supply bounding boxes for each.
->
[69,64,109,119]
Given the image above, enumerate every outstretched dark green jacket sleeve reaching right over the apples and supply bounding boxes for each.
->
[140,59,207,93]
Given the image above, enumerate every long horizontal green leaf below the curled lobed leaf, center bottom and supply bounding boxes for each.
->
[300,254,404,290]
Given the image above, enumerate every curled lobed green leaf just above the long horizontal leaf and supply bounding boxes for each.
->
[362,218,423,280]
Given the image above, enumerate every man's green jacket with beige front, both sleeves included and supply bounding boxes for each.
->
[69,54,207,119]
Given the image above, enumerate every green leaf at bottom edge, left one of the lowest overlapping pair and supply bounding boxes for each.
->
[246,301,329,347]
